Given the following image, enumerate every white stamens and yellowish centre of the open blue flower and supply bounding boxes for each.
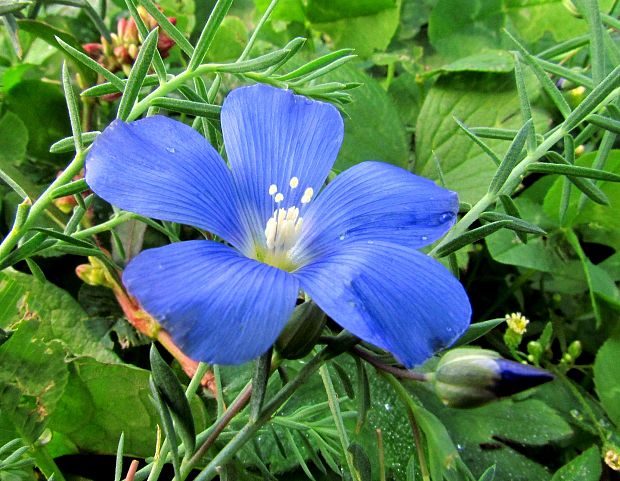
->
[261,177,314,271]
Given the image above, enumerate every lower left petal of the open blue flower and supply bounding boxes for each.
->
[123,240,298,364]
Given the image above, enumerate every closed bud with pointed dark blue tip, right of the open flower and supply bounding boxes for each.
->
[432,348,553,408]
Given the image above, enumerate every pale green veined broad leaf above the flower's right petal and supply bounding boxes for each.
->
[415,73,545,204]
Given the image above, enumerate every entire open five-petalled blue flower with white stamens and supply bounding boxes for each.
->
[86,85,471,366]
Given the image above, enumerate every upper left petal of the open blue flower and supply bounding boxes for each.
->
[86,116,247,248]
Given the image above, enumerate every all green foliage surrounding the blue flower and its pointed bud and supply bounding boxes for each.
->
[0,0,620,481]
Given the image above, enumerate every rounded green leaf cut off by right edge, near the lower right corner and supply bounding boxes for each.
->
[594,334,620,425]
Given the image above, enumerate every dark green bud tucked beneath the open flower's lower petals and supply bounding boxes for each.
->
[276,301,325,359]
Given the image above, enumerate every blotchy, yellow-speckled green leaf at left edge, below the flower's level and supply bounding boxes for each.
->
[0,314,68,444]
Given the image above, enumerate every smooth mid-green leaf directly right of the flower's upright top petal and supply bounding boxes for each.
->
[324,66,409,172]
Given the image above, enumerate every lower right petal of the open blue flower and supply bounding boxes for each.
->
[294,241,471,367]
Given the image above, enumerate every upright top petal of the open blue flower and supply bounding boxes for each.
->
[221,85,343,246]
